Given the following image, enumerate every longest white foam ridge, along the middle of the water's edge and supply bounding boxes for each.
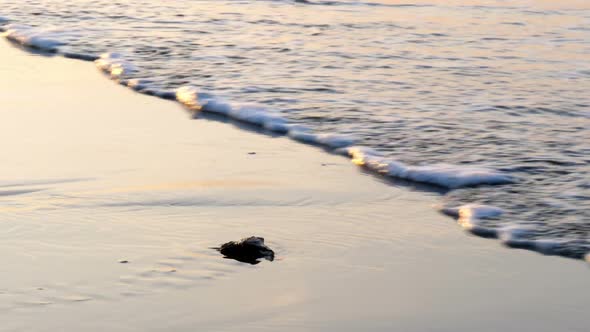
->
[176,86,514,189]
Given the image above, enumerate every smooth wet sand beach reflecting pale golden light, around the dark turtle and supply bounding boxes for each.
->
[0,42,590,332]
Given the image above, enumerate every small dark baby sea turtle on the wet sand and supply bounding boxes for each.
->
[213,236,275,265]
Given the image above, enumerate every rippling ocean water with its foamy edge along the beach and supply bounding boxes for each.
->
[0,0,590,258]
